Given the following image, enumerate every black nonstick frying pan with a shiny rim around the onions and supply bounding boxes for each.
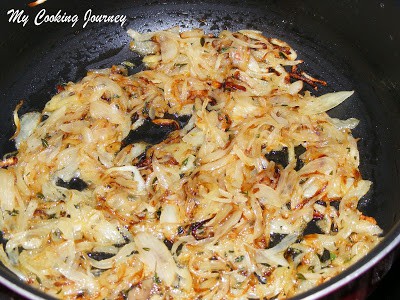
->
[0,0,400,299]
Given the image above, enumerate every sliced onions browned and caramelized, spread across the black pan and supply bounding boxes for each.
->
[0,27,382,300]
